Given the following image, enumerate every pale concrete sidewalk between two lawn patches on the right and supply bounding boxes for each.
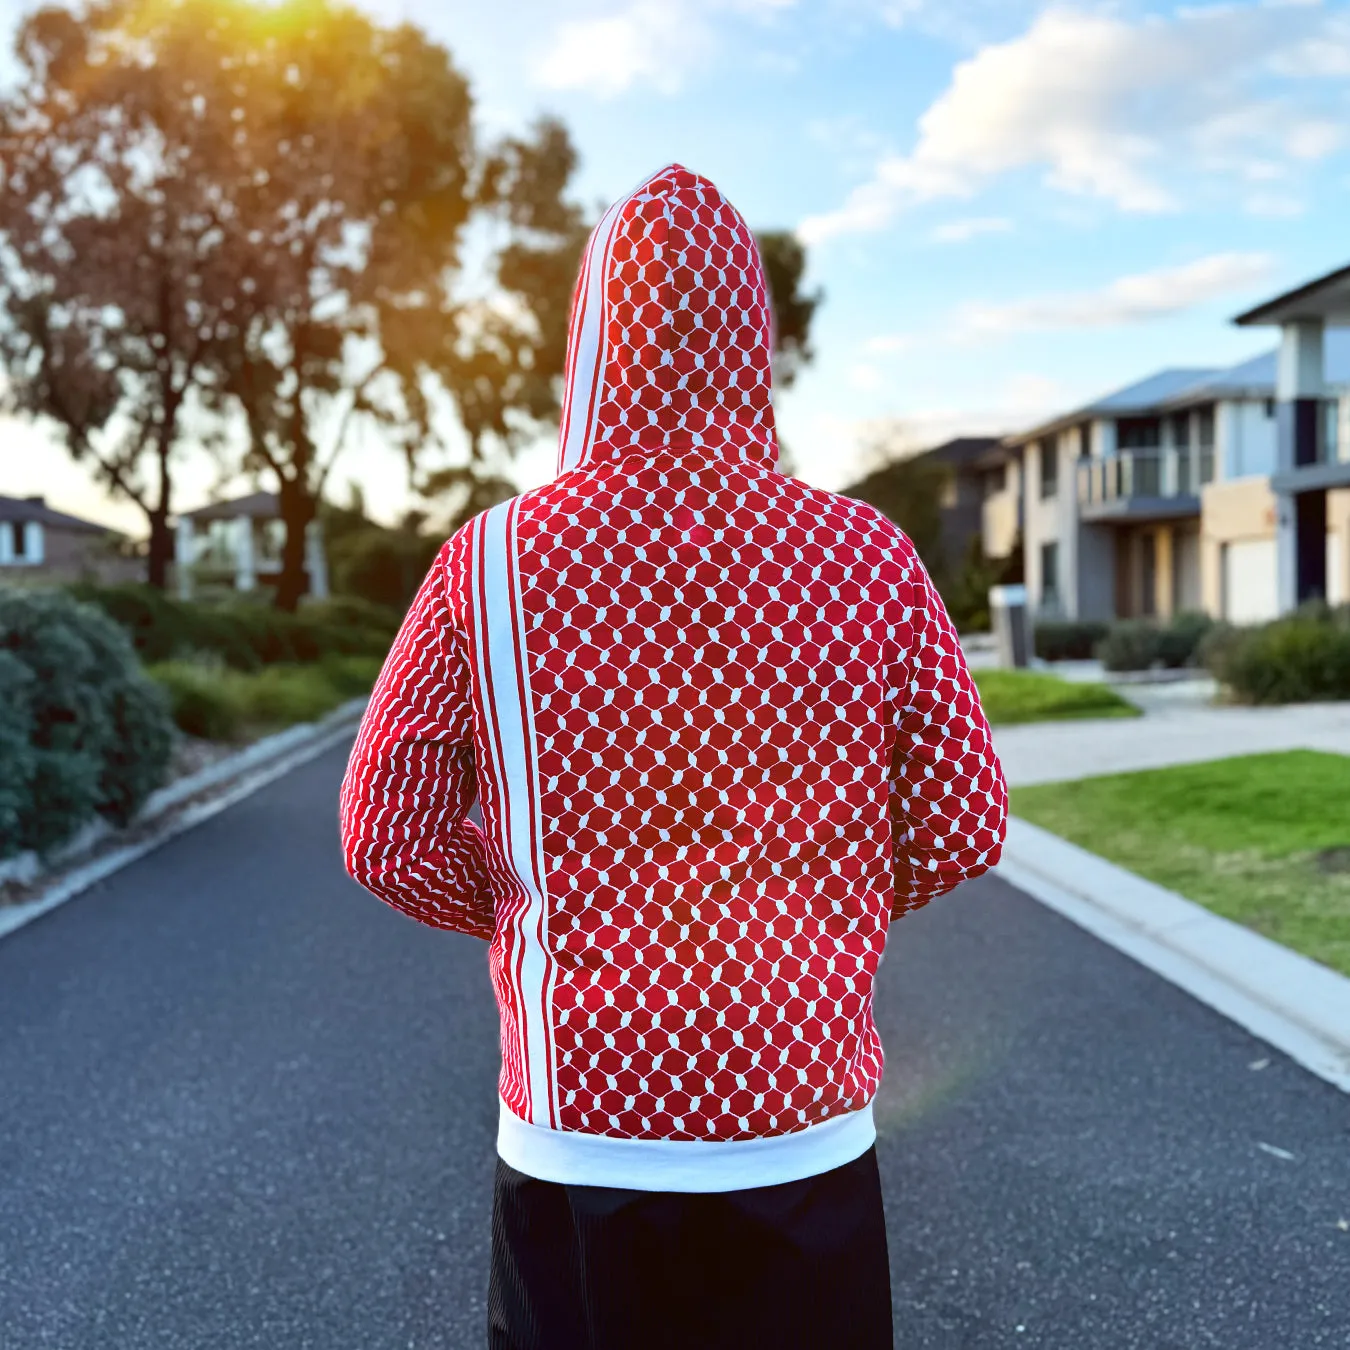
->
[994,690,1350,787]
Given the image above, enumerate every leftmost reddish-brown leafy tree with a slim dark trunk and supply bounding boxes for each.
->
[0,0,248,587]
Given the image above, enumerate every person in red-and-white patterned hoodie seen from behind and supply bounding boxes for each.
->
[342,165,1006,1350]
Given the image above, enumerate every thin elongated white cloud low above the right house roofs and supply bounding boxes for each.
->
[950,252,1270,340]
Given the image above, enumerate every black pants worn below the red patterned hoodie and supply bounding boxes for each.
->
[487,1149,891,1350]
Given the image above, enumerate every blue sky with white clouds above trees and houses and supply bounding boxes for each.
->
[0,0,1350,528]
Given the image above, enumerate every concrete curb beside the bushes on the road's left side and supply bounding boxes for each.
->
[0,698,366,938]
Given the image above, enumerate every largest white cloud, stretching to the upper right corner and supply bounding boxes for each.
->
[799,0,1350,243]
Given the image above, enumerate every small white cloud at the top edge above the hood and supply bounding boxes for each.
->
[535,0,797,97]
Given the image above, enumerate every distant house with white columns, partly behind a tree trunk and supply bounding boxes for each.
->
[174,493,328,599]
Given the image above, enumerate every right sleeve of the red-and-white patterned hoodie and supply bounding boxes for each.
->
[891,544,1007,918]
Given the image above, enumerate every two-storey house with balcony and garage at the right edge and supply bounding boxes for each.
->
[1006,269,1350,622]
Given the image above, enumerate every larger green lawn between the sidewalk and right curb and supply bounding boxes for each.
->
[1013,751,1350,975]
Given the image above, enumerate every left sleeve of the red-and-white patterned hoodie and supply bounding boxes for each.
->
[340,544,493,938]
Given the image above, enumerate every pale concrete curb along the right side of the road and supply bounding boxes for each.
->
[998,817,1350,1092]
